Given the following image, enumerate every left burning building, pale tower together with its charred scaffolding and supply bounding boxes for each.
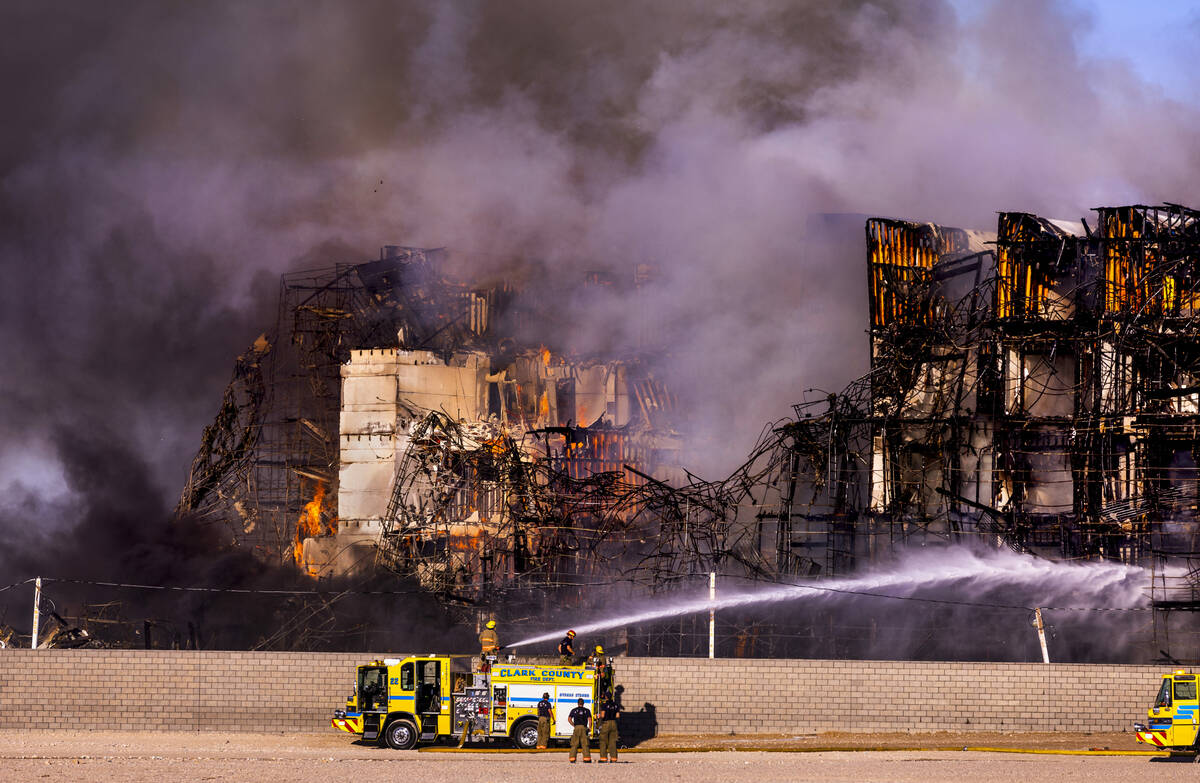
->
[179,247,682,602]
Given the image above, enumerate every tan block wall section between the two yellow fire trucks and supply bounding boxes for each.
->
[616,658,1166,734]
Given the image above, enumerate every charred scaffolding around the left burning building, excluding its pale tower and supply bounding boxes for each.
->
[178,246,691,604]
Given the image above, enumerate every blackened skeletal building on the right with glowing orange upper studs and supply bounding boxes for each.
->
[729,204,1200,642]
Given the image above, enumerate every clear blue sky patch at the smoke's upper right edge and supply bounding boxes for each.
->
[952,0,1200,102]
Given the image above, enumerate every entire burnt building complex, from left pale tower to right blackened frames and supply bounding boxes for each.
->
[179,204,1200,662]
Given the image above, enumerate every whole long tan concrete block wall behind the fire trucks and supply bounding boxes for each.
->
[0,650,1165,735]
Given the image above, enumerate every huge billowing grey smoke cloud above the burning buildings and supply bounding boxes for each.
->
[0,0,1200,578]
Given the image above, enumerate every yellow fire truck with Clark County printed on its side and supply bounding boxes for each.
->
[332,655,599,751]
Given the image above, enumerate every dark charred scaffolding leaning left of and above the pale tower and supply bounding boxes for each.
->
[176,246,477,563]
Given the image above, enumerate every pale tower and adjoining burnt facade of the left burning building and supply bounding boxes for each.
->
[304,348,678,596]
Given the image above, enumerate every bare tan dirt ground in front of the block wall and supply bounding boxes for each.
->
[0,730,1180,783]
